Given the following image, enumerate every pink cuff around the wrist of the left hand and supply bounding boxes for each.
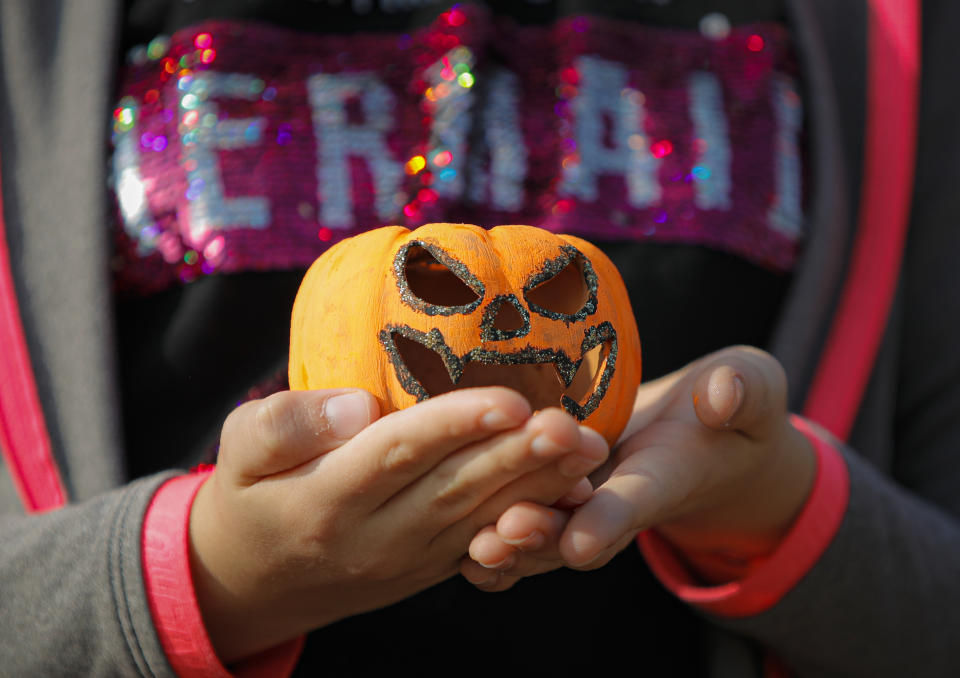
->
[141,472,303,678]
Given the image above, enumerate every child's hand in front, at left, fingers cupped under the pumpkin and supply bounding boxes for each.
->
[190,388,608,662]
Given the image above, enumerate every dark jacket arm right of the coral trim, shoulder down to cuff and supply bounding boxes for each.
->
[640,1,960,677]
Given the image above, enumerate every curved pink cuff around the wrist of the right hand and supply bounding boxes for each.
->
[637,416,850,617]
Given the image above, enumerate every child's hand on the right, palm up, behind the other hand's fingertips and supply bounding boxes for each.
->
[461,347,814,590]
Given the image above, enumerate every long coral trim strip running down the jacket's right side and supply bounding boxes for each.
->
[804,0,920,440]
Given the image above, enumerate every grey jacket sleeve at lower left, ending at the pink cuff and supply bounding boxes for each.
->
[0,475,174,678]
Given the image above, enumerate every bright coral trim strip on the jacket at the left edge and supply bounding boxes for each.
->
[0,162,67,513]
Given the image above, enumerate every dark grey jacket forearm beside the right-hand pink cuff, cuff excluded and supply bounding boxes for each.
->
[715,440,960,676]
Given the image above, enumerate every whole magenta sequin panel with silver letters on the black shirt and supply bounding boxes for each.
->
[112,7,803,292]
